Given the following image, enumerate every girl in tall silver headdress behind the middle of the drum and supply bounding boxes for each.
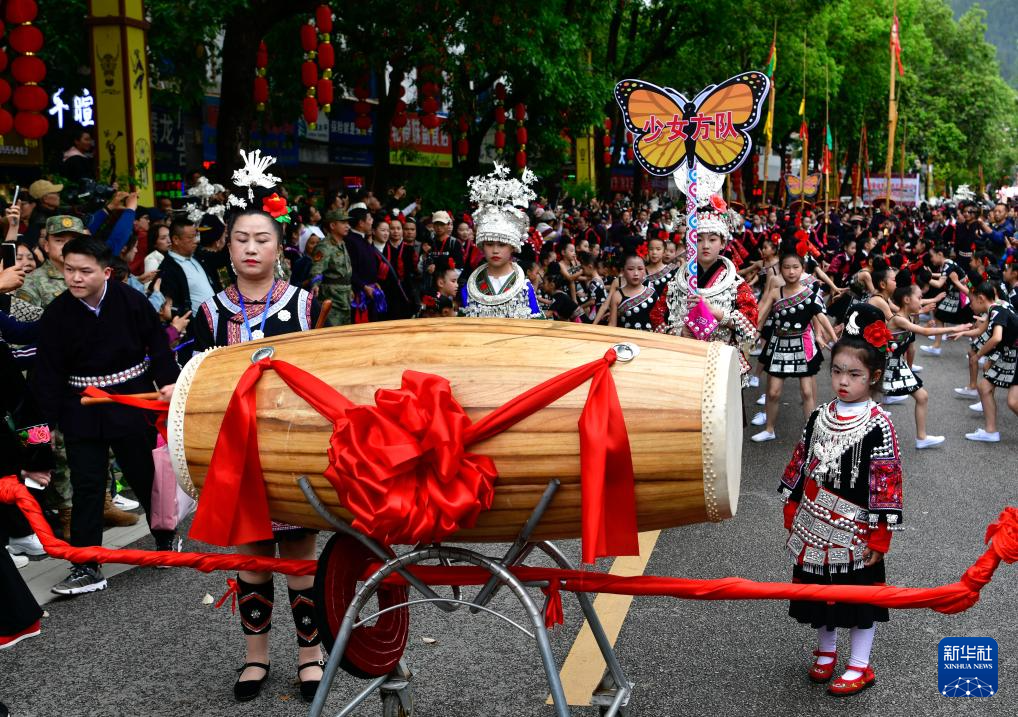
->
[460,164,544,319]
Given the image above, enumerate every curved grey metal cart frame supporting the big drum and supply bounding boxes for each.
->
[297,476,633,717]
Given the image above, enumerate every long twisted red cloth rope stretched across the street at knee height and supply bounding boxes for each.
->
[0,476,1018,621]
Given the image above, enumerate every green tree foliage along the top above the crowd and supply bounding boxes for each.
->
[33,0,1018,188]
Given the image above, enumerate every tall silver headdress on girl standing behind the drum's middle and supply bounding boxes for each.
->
[467,162,538,252]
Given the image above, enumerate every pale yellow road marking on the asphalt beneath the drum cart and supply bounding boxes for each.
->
[548,531,661,707]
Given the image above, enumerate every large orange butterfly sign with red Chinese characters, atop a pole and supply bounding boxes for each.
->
[615,71,771,176]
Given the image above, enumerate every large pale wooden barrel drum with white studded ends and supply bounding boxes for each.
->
[169,319,742,542]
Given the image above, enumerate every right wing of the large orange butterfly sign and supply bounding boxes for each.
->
[694,72,771,174]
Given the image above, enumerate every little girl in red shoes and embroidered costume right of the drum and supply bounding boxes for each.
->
[779,304,902,695]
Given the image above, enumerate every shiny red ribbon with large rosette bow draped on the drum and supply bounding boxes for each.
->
[190,349,639,563]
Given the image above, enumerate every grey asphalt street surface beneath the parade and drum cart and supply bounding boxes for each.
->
[0,342,1018,717]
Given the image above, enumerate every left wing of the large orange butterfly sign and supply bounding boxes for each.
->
[615,79,686,176]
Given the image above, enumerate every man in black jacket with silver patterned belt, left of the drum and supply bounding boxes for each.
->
[33,236,180,595]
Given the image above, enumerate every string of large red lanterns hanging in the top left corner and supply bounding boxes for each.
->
[0,0,50,143]
